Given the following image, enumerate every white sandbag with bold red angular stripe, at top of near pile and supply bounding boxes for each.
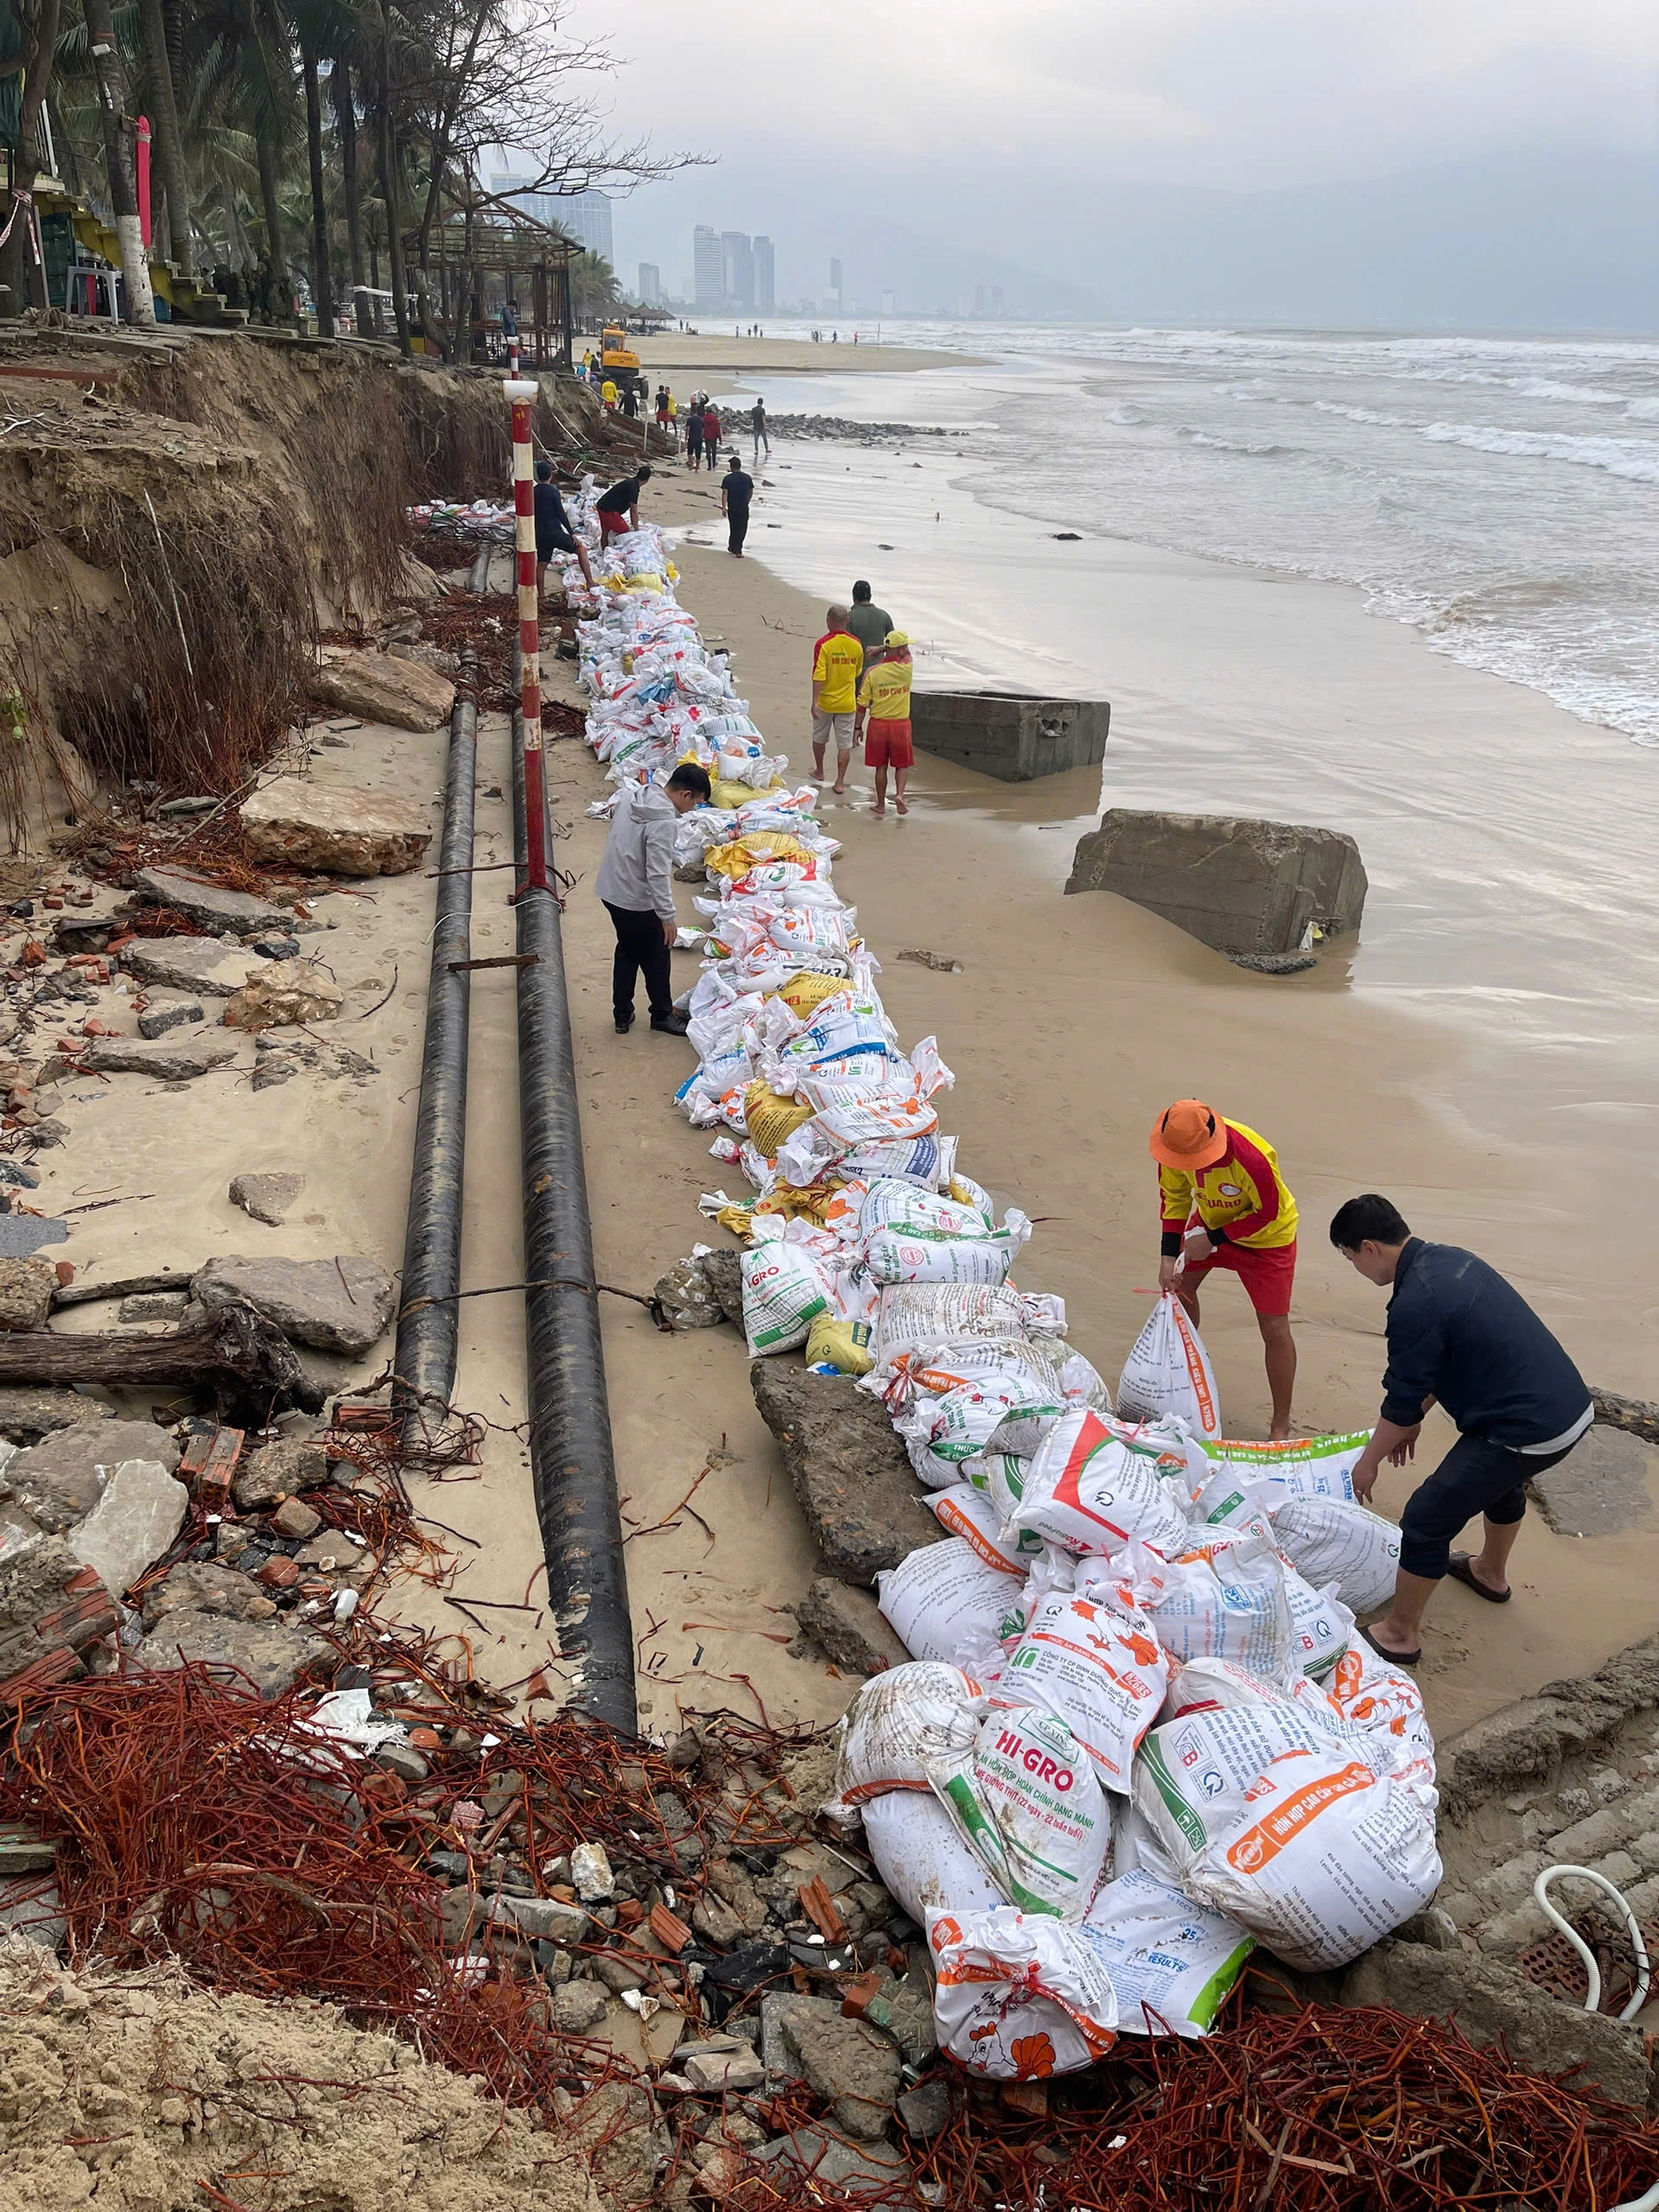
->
[1008,1407,1192,1553]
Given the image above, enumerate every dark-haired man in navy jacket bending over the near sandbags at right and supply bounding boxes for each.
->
[1332,1192,1595,1666]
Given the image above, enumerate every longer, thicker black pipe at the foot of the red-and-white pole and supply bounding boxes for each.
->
[513,715,637,1734]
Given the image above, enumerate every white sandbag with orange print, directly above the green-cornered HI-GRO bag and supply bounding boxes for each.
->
[991,1575,1170,1796]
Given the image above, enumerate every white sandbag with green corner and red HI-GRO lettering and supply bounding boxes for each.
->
[925,1707,1113,1920]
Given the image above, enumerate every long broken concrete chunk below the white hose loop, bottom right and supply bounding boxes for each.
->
[1343,1942,1652,2108]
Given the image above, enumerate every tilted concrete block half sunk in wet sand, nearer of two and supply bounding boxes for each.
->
[1066,807,1367,957]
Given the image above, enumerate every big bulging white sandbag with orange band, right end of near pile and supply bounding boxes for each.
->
[1181,1754,1440,1974]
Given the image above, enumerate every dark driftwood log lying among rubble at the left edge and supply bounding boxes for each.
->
[0,1305,323,1421]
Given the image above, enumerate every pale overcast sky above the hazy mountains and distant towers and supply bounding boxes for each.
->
[553,0,1659,311]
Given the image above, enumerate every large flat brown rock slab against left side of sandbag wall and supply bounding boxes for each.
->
[750,1360,943,1584]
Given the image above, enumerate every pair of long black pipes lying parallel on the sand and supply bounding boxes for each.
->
[391,593,637,1734]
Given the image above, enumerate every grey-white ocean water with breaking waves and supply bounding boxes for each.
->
[766,323,1659,746]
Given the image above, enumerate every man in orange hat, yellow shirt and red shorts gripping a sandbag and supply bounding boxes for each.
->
[1150,1099,1296,1440]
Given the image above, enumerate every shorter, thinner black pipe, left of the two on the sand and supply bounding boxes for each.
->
[391,652,478,1445]
